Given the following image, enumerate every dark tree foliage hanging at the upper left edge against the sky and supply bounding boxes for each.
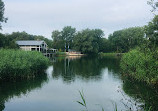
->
[0,0,7,29]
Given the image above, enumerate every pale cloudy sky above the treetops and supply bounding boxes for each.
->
[0,0,153,39]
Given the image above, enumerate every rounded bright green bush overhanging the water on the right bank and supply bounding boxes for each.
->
[120,49,158,84]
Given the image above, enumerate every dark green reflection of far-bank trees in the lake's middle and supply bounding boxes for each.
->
[52,57,119,83]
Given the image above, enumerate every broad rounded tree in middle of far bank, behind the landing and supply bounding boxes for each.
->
[74,29,104,54]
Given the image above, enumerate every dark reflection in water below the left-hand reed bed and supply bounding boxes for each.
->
[0,74,48,111]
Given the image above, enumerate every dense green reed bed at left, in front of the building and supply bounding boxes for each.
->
[0,49,49,79]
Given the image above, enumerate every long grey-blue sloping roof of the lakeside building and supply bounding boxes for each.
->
[16,40,44,46]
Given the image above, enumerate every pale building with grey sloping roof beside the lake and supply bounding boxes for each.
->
[16,40,48,53]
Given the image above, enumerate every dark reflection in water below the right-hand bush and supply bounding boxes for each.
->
[123,78,158,111]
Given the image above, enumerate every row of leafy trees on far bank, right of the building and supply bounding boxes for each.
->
[52,26,145,54]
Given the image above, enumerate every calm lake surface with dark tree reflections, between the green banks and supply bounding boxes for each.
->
[0,57,158,111]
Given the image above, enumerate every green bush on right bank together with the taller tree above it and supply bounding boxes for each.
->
[121,15,158,85]
